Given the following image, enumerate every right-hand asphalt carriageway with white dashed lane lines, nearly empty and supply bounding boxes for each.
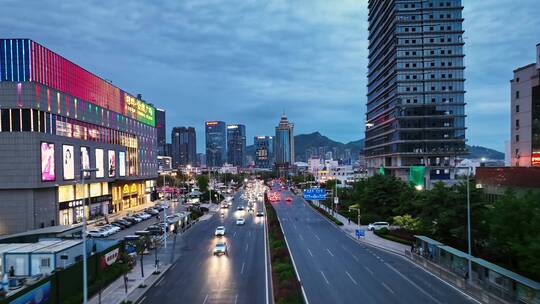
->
[273,191,476,304]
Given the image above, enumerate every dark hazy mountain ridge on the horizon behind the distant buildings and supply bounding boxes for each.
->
[246,132,504,161]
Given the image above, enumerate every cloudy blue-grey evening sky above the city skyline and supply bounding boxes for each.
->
[0,0,540,152]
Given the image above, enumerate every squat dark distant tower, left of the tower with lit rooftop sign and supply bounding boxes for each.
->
[171,127,197,168]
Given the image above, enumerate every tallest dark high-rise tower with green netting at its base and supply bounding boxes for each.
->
[364,0,466,187]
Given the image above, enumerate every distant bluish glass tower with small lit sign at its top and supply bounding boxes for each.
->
[205,121,227,168]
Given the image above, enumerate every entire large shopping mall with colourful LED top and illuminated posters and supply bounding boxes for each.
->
[0,39,158,235]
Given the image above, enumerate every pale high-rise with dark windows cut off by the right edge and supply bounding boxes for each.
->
[510,43,540,167]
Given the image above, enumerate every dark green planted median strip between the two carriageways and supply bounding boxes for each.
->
[265,199,304,304]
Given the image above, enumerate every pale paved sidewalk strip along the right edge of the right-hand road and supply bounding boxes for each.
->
[306,202,410,255]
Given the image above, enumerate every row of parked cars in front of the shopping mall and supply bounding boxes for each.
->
[87,204,169,238]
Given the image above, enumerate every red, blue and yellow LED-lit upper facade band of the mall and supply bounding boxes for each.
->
[0,39,155,127]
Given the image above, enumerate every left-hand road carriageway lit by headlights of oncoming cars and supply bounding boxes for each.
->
[140,192,272,304]
